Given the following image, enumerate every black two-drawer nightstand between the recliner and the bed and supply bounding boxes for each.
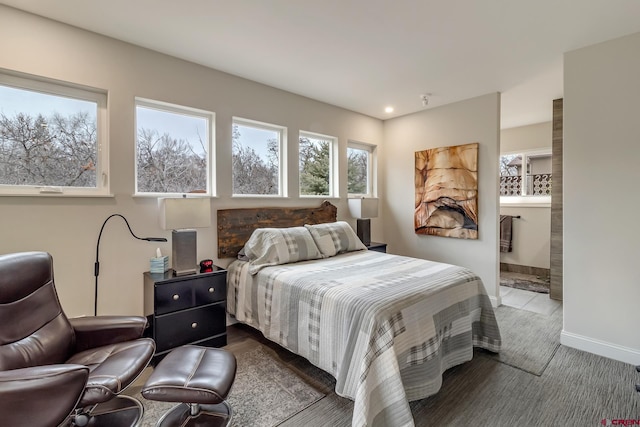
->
[144,267,227,356]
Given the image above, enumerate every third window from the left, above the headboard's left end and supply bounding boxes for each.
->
[232,117,286,196]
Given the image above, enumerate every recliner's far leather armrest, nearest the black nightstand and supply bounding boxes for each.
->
[69,316,147,352]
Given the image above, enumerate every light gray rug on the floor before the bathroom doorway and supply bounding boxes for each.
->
[487,305,562,376]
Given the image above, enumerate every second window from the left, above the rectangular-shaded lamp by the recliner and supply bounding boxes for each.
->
[136,98,214,195]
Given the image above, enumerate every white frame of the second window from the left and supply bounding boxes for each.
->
[133,96,216,198]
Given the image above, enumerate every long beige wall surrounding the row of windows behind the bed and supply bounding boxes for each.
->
[0,6,384,316]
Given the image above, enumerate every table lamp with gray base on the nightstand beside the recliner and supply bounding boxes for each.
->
[159,196,211,276]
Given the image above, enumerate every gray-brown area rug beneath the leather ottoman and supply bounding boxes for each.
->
[135,345,325,427]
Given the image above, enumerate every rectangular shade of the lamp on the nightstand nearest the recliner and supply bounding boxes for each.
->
[160,197,211,230]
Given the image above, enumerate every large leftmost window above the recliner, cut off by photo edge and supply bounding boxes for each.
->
[0,73,109,196]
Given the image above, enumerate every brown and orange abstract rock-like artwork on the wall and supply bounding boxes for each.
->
[413,142,479,239]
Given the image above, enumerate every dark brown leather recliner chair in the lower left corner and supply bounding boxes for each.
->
[0,252,155,427]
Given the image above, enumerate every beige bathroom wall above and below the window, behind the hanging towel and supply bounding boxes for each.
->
[500,121,553,268]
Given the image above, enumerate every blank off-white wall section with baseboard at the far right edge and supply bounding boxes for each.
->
[562,33,640,364]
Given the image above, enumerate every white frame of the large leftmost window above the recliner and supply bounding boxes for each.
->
[0,69,113,197]
